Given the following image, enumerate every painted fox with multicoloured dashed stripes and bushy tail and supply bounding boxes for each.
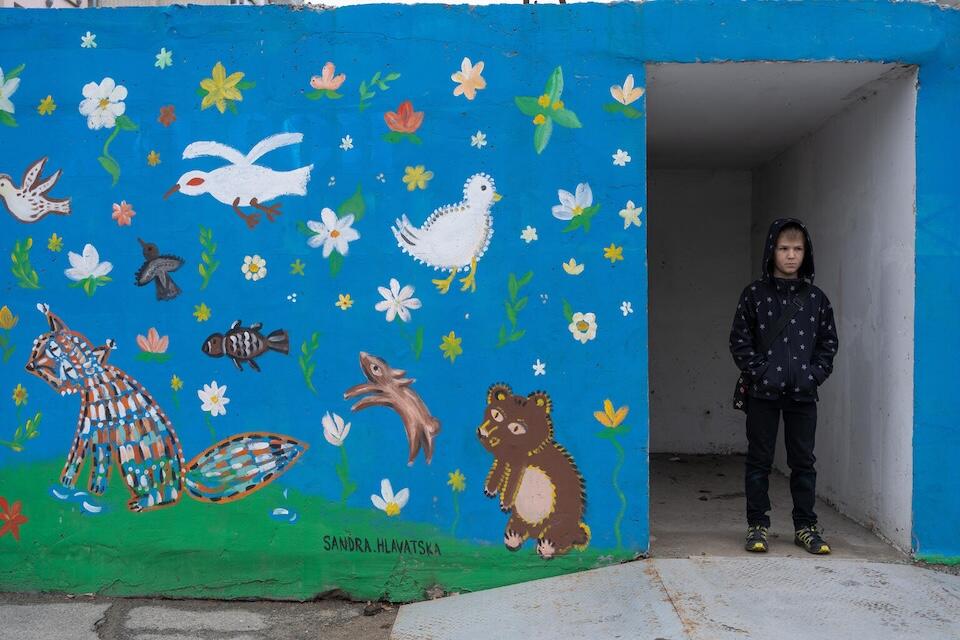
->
[26,304,307,511]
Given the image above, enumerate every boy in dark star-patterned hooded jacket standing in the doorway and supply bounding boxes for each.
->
[730,218,838,554]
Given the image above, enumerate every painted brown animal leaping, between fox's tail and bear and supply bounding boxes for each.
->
[343,351,440,466]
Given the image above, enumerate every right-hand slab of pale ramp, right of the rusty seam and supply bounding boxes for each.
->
[654,556,960,640]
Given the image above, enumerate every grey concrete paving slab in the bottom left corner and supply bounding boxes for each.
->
[0,602,110,640]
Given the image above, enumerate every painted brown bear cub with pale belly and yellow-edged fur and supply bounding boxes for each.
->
[477,384,590,559]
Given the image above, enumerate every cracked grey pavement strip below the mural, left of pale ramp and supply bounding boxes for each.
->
[0,594,397,640]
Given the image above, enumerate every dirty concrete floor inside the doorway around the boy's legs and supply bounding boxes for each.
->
[650,453,910,562]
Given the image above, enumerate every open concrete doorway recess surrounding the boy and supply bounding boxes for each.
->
[647,62,917,561]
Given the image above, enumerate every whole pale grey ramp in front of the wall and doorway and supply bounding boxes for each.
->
[392,555,960,640]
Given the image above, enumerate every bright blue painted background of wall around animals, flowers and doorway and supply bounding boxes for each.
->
[0,2,960,600]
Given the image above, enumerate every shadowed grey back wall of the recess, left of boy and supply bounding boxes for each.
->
[647,169,754,453]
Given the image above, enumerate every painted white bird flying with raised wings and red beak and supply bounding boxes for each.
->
[163,133,313,229]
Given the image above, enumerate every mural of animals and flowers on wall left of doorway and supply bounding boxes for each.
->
[0,8,647,599]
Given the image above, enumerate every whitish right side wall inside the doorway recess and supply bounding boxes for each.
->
[752,69,917,549]
